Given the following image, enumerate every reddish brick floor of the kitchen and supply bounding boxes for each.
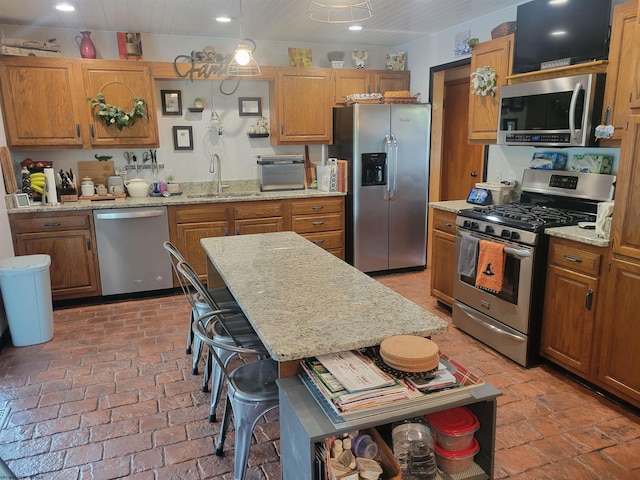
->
[0,271,640,480]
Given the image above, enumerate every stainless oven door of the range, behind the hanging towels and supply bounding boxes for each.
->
[453,227,535,335]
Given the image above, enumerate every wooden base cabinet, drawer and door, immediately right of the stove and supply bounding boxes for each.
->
[540,237,607,375]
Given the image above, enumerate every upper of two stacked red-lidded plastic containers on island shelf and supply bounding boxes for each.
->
[427,407,480,452]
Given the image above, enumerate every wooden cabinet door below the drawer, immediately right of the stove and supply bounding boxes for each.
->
[540,265,598,374]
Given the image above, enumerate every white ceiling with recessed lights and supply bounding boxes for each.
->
[0,0,526,47]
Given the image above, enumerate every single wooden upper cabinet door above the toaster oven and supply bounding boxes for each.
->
[271,68,333,145]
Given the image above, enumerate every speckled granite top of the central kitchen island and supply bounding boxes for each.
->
[201,232,448,362]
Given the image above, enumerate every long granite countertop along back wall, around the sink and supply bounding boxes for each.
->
[6,180,346,214]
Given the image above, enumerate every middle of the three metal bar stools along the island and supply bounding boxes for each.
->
[177,262,269,422]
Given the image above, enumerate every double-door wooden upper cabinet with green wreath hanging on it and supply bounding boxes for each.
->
[0,57,159,150]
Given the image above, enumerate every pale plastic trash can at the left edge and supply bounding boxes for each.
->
[0,255,53,347]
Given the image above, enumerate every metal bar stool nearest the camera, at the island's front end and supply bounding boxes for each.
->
[193,311,278,480]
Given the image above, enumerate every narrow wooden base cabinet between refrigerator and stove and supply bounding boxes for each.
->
[431,209,456,307]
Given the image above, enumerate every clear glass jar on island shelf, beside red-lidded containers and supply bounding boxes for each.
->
[391,417,438,480]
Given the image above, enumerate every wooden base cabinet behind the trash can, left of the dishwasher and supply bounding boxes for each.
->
[9,211,101,300]
